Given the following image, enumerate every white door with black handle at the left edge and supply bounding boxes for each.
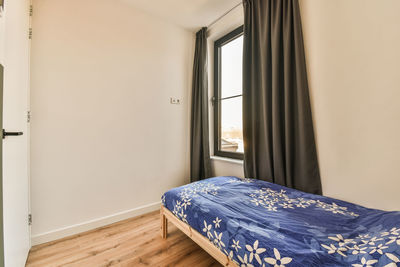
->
[1,0,30,267]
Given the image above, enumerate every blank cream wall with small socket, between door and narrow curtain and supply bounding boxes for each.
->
[31,0,194,244]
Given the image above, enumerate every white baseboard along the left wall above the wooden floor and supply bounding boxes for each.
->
[31,202,161,246]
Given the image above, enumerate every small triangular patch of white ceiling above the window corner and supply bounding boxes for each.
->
[117,0,241,31]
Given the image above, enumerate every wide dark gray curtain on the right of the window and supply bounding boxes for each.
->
[243,0,322,194]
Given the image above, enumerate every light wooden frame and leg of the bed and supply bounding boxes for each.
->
[160,206,238,267]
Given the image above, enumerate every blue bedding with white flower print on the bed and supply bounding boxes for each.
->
[162,177,400,267]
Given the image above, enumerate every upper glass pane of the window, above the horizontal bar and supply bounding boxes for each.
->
[221,36,243,98]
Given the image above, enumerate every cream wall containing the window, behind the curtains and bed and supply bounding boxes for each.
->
[209,0,400,210]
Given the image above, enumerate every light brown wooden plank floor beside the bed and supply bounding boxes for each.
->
[27,211,221,267]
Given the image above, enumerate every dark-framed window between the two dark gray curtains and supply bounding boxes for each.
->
[213,27,243,159]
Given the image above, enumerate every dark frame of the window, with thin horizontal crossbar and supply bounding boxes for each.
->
[213,25,244,160]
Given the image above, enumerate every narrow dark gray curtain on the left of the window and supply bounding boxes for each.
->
[190,28,211,182]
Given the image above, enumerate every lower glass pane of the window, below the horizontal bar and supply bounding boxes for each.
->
[219,96,243,153]
